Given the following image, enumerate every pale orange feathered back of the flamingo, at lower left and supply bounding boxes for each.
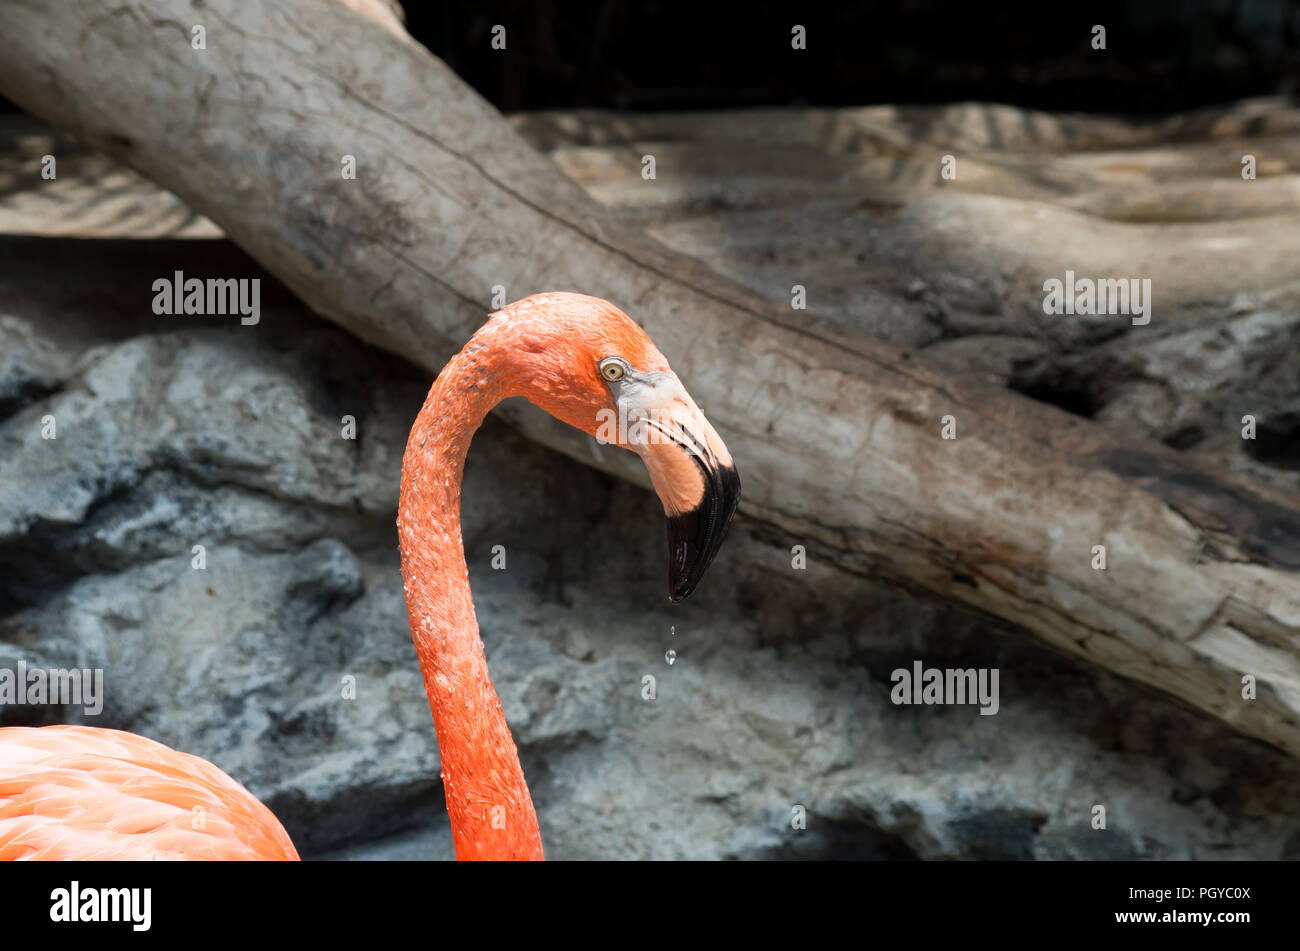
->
[0,726,298,860]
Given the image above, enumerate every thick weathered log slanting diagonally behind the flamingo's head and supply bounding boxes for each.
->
[0,0,1300,754]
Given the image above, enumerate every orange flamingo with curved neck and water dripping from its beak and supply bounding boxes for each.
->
[0,292,740,860]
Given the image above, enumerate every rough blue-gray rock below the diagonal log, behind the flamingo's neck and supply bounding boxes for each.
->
[0,249,1300,859]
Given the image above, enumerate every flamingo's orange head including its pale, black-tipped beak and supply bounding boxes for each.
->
[493,294,740,603]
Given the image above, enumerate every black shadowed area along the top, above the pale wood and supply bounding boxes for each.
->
[395,0,1300,114]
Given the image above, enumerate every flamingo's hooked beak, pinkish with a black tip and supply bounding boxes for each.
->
[634,383,740,604]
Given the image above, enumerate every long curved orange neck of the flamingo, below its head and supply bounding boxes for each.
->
[398,323,542,859]
